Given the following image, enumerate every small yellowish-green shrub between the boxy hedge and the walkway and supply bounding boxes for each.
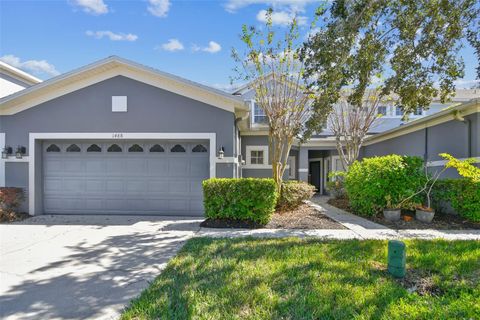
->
[277,181,315,211]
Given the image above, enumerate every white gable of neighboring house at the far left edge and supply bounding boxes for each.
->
[0,61,42,98]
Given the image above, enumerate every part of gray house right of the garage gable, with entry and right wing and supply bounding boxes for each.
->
[233,81,480,193]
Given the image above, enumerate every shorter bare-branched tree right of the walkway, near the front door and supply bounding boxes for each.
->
[327,90,380,169]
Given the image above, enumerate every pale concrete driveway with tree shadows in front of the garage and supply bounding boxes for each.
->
[0,216,201,319]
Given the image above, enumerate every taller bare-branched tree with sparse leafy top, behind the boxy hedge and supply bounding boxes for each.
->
[232,10,311,190]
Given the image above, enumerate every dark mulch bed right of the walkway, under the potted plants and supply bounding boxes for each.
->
[327,199,480,230]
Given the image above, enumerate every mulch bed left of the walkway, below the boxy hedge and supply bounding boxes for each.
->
[200,204,345,229]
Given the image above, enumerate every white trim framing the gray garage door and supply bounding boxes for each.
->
[28,132,217,215]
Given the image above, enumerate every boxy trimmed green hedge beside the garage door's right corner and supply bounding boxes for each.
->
[203,178,278,224]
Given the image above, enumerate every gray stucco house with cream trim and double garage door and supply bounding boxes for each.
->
[0,57,480,215]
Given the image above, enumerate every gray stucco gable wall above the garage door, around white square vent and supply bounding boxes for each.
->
[0,76,234,157]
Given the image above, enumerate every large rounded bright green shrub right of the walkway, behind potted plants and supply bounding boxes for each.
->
[345,155,425,215]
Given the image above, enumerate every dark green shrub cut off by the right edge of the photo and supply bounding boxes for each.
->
[432,179,480,222]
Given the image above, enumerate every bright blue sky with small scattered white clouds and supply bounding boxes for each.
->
[0,0,476,88]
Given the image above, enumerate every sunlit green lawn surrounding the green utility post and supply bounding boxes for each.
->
[122,238,480,320]
